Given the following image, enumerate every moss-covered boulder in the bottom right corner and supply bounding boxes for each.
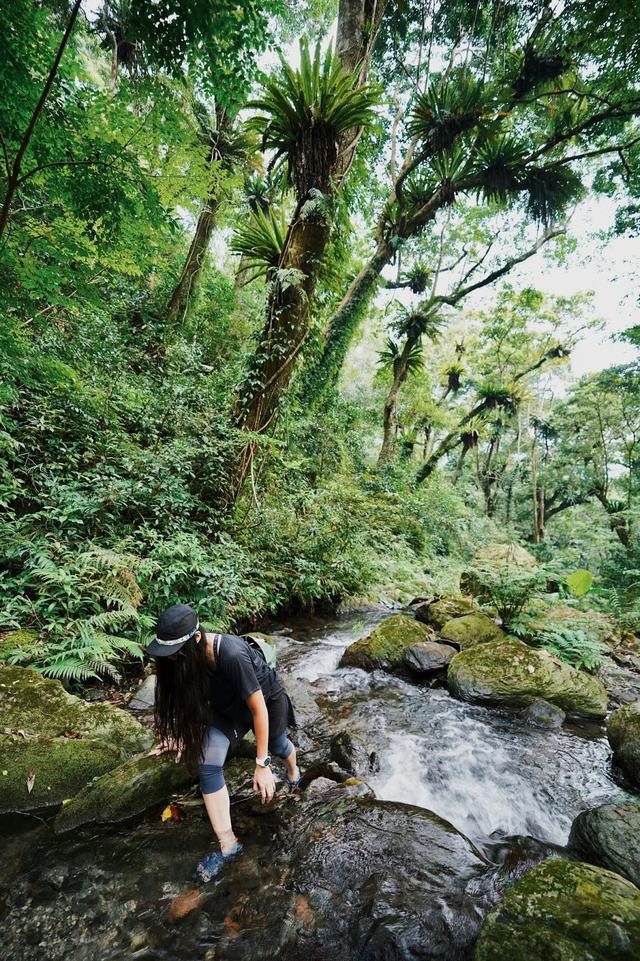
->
[473,860,640,961]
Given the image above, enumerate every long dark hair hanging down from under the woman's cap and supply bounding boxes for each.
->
[154,635,211,768]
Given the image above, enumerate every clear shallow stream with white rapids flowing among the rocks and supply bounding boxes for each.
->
[0,610,624,961]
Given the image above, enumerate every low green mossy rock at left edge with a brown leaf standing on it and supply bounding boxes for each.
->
[0,735,125,814]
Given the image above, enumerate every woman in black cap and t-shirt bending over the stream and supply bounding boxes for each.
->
[148,604,300,881]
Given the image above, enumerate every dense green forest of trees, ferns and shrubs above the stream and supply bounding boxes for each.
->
[0,0,640,678]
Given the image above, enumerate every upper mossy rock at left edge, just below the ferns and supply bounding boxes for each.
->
[0,666,153,754]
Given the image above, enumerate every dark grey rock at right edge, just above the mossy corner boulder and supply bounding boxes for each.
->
[569,801,640,886]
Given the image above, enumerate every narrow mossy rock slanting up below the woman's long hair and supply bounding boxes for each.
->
[55,754,195,831]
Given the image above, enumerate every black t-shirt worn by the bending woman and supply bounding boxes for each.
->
[208,634,282,726]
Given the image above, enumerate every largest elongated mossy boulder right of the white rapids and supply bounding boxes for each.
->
[447,637,607,718]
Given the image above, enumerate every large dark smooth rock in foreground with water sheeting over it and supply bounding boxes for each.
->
[287,789,500,961]
